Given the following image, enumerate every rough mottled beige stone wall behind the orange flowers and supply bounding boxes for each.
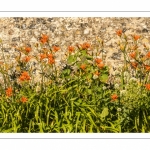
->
[0,18,150,71]
